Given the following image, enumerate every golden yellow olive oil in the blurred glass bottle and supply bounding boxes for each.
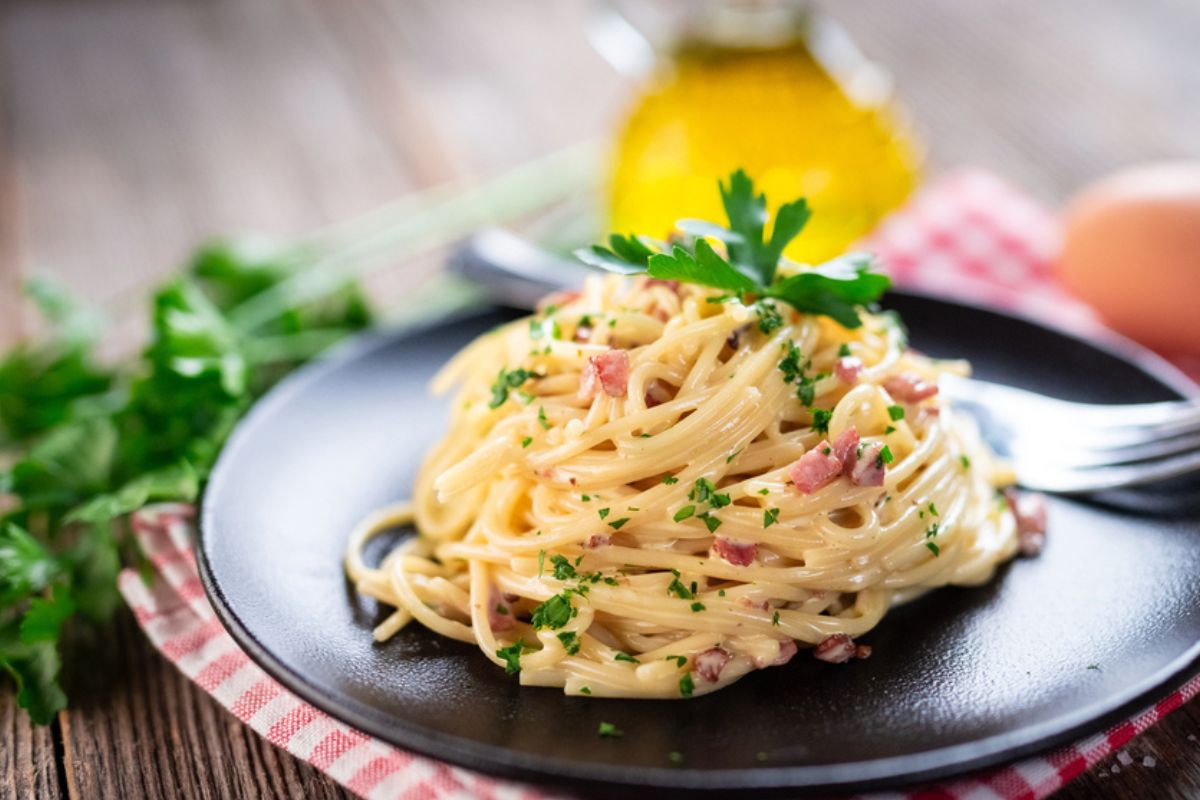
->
[610,34,918,263]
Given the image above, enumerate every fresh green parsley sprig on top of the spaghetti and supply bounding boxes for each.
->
[576,169,890,327]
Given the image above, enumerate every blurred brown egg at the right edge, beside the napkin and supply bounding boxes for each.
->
[1057,162,1200,355]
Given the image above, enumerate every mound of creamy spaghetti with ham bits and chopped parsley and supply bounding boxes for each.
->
[346,276,1018,698]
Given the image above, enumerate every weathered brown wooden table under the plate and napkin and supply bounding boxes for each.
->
[0,0,1200,799]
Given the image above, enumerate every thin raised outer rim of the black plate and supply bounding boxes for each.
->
[194,289,1200,793]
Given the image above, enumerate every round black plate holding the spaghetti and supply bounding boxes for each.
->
[199,295,1200,796]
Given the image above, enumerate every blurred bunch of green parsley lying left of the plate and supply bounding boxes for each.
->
[0,242,371,723]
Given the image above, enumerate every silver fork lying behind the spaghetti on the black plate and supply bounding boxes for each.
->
[450,229,1200,494]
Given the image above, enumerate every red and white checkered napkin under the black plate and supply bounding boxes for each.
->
[120,172,1200,800]
